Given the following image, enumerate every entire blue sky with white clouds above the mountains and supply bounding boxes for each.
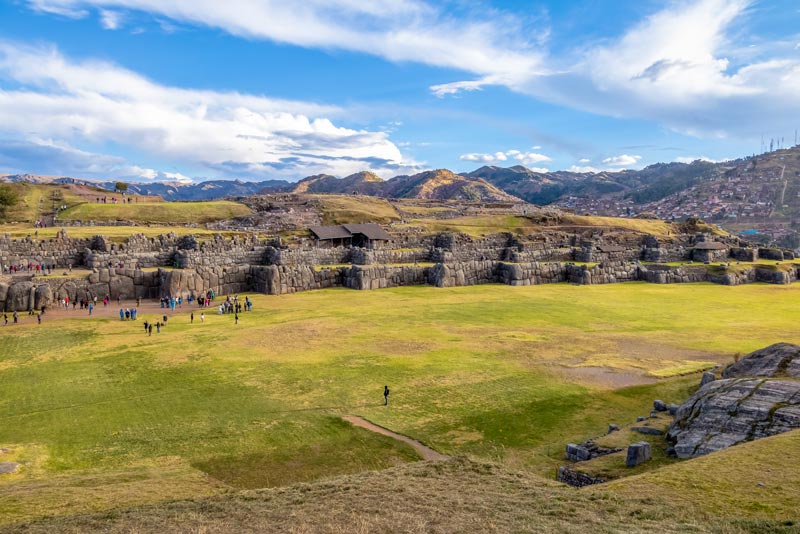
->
[0,0,800,182]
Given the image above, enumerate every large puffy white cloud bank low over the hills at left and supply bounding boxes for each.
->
[0,42,416,179]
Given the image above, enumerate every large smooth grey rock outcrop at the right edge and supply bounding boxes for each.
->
[667,343,800,458]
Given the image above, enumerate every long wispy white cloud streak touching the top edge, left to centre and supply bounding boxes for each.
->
[28,0,540,84]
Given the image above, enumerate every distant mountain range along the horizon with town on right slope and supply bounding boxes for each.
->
[0,147,800,218]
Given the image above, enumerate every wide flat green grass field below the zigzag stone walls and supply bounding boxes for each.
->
[0,283,800,522]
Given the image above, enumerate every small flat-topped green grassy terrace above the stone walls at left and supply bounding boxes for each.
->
[58,200,252,224]
